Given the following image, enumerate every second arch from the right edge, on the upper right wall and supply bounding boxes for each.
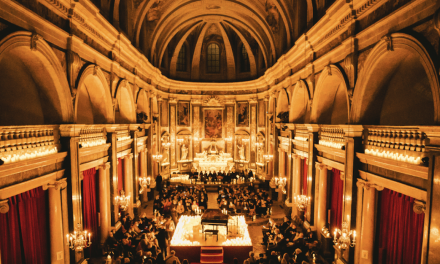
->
[310,64,350,124]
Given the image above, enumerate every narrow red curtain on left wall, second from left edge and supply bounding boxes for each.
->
[83,168,100,257]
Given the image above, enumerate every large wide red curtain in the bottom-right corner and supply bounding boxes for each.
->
[378,189,425,264]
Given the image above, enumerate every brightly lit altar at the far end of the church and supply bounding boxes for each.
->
[193,142,235,172]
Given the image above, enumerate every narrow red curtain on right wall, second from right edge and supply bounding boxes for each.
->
[327,169,344,233]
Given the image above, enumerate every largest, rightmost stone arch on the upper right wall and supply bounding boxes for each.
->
[351,33,440,125]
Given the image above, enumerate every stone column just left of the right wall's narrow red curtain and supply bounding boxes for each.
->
[316,163,327,237]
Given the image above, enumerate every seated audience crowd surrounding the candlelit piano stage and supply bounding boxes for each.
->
[105,174,319,264]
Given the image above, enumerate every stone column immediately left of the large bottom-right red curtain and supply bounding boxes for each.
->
[359,183,383,264]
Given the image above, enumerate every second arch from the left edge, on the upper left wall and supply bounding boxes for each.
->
[75,65,114,124]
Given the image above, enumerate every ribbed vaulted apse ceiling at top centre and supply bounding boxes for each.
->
[107,0,319,81]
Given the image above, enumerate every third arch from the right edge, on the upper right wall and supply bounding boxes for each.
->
[289,80,310,123]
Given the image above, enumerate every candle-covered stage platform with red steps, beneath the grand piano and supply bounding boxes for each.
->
[170,210,253,263]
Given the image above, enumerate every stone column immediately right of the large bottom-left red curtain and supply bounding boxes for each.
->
[47,179,67,264]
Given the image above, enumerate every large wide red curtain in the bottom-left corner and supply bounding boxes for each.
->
[0,187,50,264]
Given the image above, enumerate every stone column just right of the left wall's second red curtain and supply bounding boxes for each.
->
[97,163,111,244]
